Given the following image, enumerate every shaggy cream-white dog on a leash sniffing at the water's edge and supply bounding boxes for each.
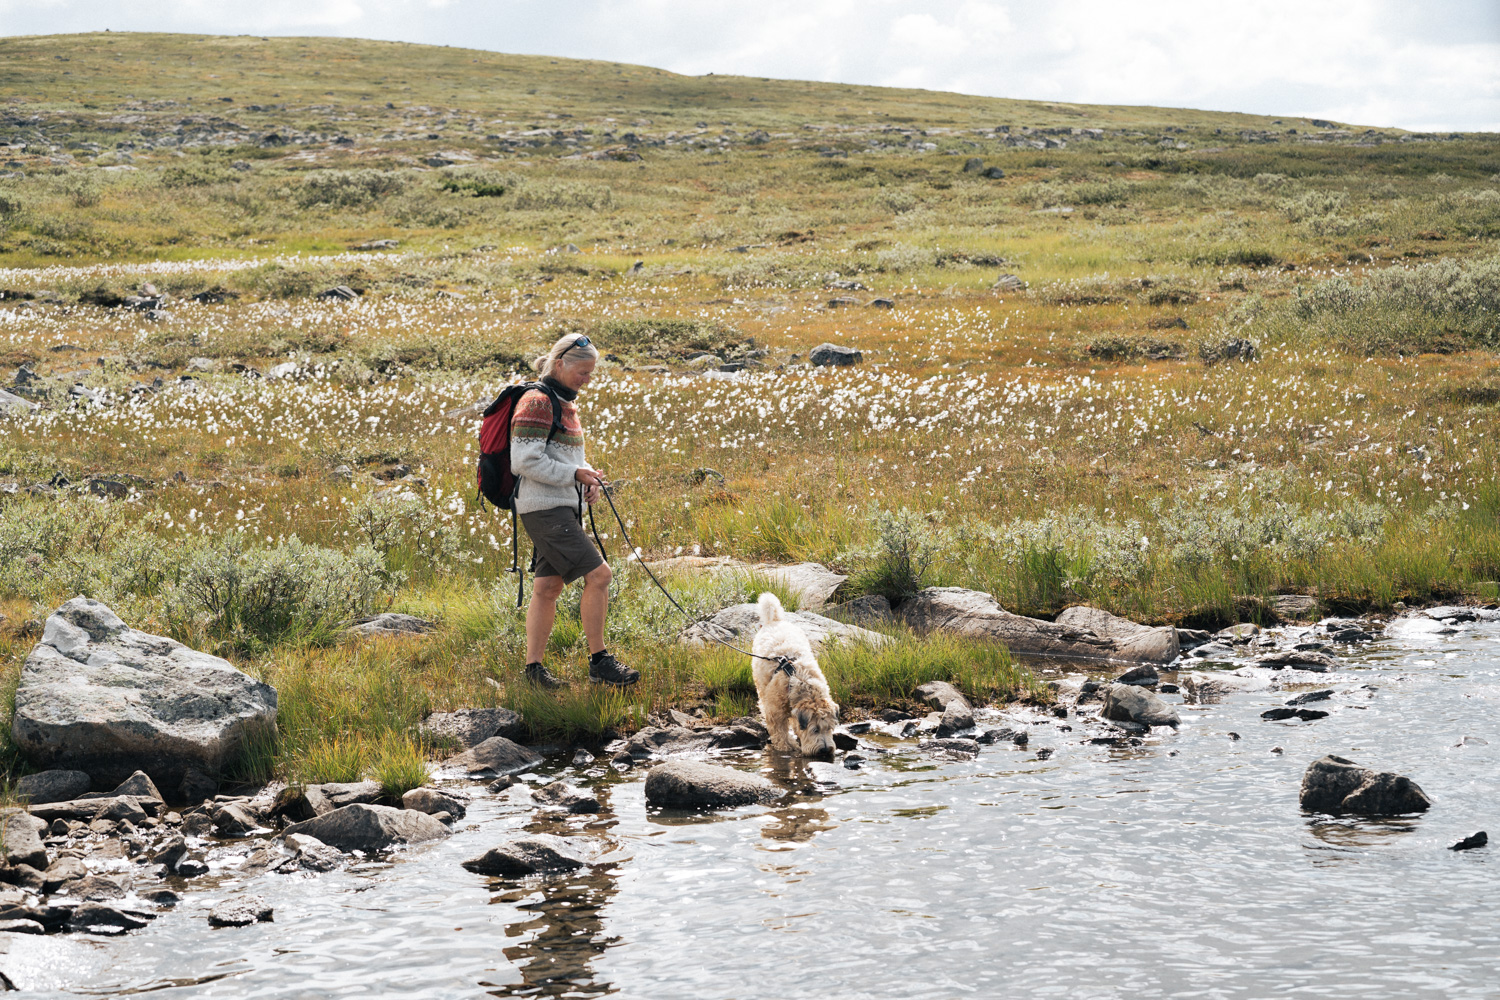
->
[750,594,839,757]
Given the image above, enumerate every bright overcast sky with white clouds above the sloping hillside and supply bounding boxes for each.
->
[0,0,1500,132]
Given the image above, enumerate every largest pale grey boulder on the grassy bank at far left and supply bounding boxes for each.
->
[11,597,276,789]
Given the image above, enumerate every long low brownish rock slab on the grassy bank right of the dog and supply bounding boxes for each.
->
[897,586,1178,663]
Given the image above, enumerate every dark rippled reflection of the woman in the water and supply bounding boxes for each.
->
[485,868,620,997]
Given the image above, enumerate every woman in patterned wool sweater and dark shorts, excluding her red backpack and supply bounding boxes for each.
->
[510,334,641,688]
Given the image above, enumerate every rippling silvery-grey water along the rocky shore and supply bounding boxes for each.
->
[0,622,1500,1000]
